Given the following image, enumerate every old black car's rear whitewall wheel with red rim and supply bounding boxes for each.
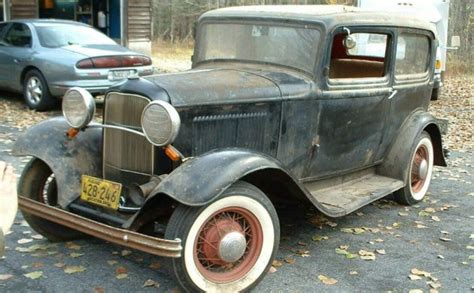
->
[394,131,434,205]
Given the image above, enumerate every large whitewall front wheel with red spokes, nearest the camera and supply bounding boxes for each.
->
[165,182,280,292]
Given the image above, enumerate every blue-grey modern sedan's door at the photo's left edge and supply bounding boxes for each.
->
[0,23,33,90]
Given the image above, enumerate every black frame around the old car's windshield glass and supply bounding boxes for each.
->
[192,17,325,78]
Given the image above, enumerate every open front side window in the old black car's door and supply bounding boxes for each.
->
[329,33,389,79]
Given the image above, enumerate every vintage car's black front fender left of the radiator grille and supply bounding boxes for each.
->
[13,117,102,208]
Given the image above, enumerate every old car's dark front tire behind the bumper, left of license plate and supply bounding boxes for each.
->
[18,158,83,241]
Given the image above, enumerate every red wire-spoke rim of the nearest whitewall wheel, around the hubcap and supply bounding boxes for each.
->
[194,207,263,283]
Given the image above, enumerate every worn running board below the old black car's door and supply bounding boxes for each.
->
[304,169,405,217]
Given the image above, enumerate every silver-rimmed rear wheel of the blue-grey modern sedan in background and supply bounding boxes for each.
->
[23,69,59,111]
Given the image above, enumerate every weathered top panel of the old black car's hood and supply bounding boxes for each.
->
[146,69,309,107]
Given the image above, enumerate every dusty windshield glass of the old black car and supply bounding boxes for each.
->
[196,23,320,73]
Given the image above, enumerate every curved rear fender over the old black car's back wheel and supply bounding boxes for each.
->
[378,110,447,182]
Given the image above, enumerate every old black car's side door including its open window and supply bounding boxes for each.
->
[307,27,394,177]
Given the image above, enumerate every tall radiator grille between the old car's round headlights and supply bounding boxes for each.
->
[103,93,154,184]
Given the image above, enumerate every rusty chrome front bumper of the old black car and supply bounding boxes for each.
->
[18,196,183,257]
